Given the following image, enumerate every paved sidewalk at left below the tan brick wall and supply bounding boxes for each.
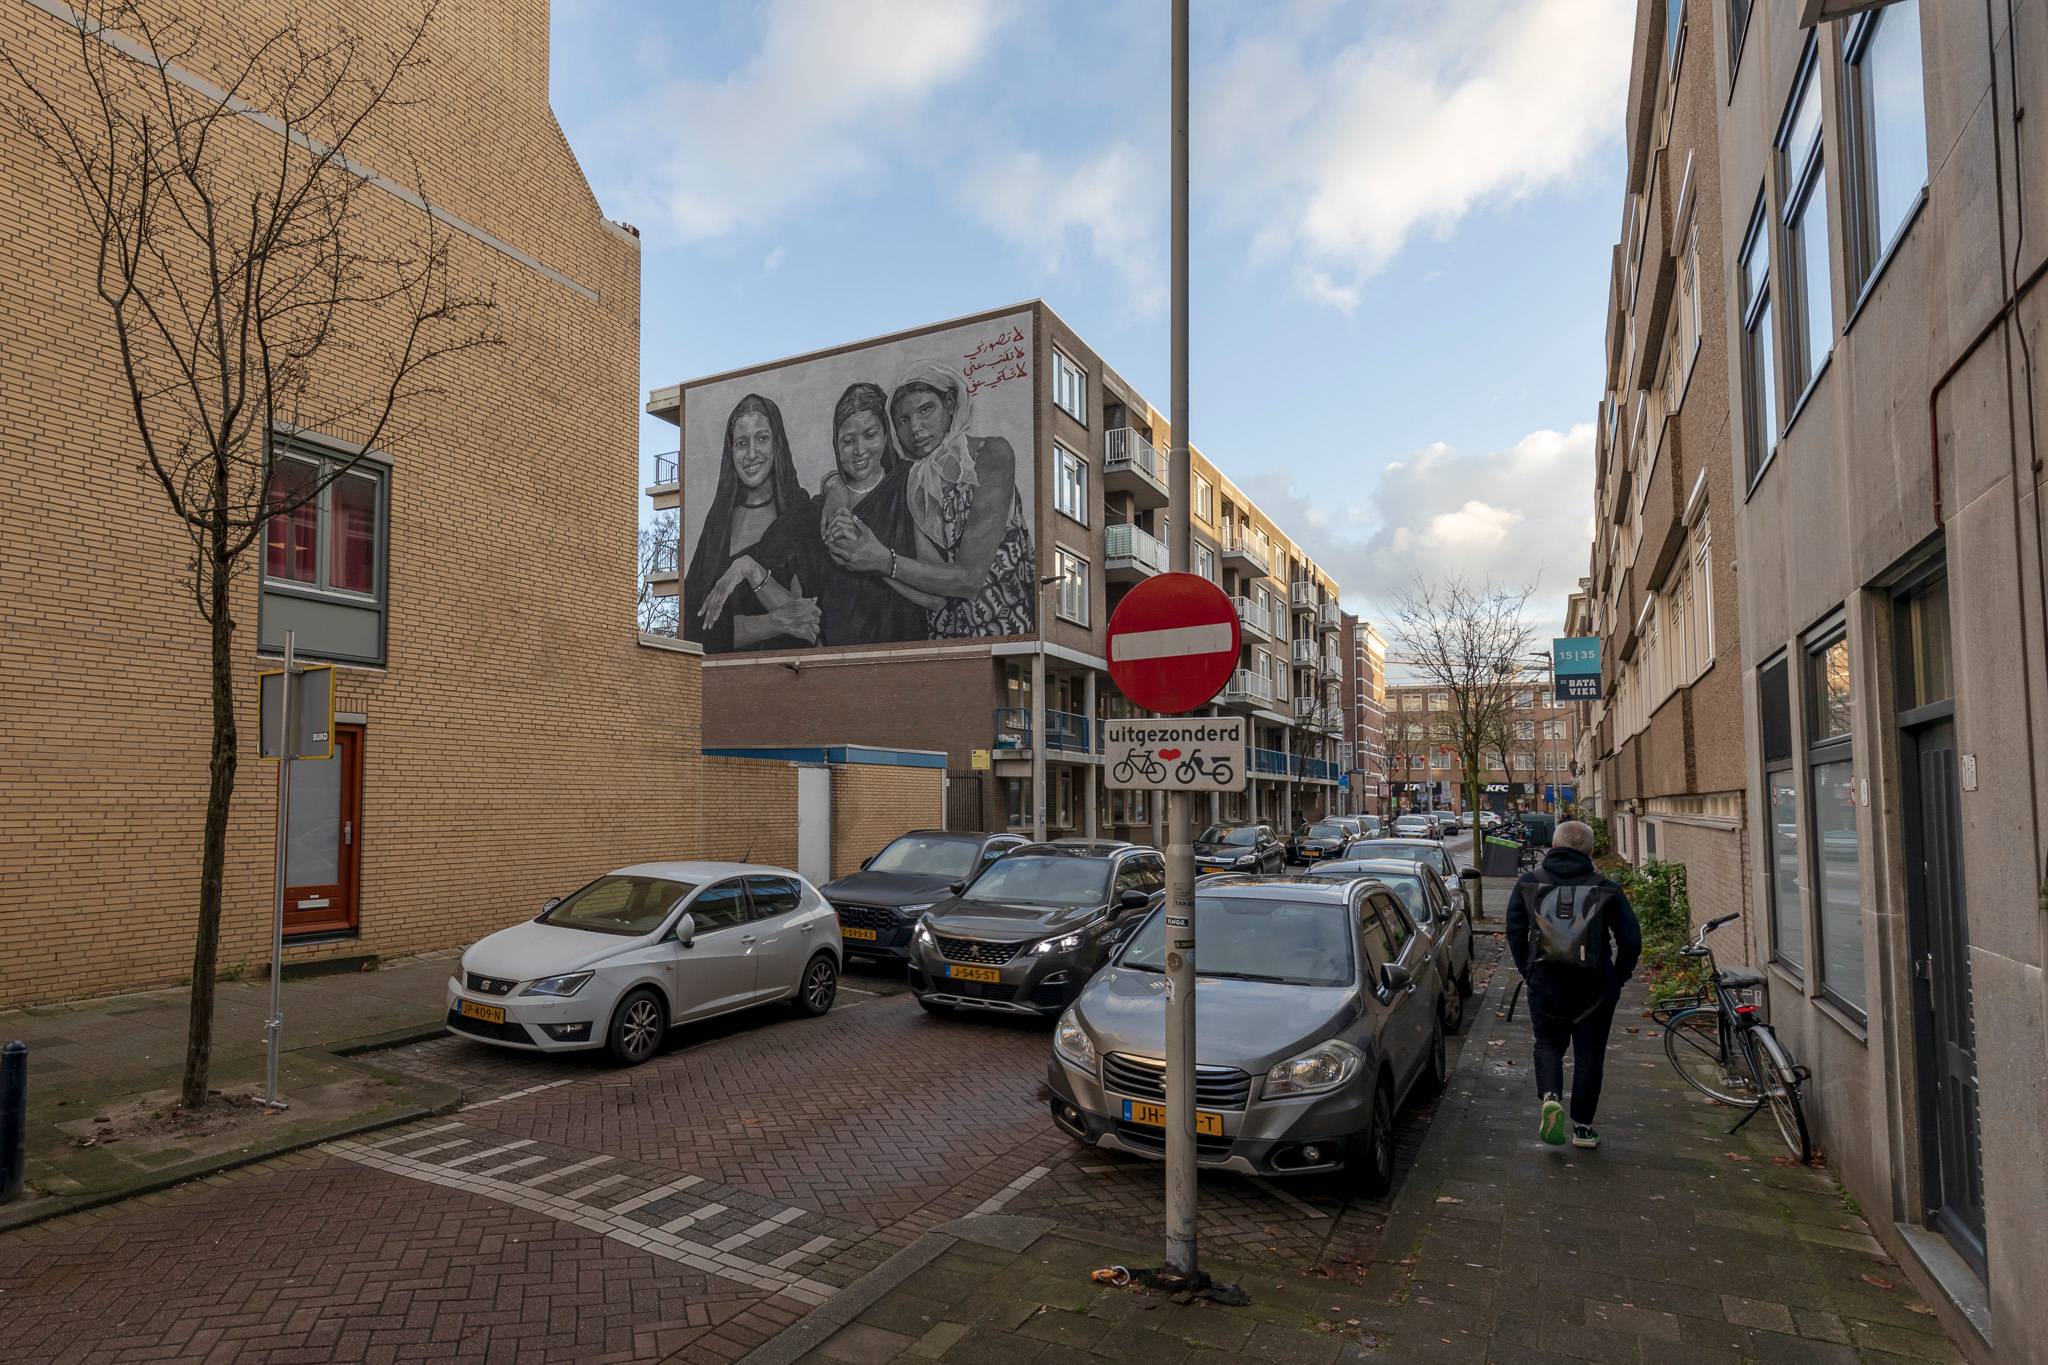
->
[0,950,459,1230]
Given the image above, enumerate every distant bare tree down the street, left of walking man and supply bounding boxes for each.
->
[1393,577,1534,915]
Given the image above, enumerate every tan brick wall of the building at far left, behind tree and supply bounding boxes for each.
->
[0,0,704,1005]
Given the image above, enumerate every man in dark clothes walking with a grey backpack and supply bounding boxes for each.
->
[1507,821,1642,1146]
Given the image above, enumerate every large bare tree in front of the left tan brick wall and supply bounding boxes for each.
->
[0,0,498,1107]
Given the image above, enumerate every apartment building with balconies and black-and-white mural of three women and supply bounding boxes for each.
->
[647,301,1346,841]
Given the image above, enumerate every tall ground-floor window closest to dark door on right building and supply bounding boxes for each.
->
[1806,626,1866,1021]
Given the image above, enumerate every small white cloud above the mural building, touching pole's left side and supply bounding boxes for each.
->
[963,141,1165,313]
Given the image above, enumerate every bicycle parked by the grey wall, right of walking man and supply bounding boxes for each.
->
[1653,915,1812,1164]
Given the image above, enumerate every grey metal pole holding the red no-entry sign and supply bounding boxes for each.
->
[1165,0,1196,1279]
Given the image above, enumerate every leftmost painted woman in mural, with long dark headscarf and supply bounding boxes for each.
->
[682,393,819,655]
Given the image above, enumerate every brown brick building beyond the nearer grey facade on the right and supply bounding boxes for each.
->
[1581,0,1749,961]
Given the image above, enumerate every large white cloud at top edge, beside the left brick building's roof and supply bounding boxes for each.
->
[602,0,1012,241]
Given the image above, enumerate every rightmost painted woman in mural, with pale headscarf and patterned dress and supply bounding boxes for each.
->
[825,360,1036,639]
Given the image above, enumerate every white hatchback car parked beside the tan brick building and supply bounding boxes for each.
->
[449,862,840,1066]
